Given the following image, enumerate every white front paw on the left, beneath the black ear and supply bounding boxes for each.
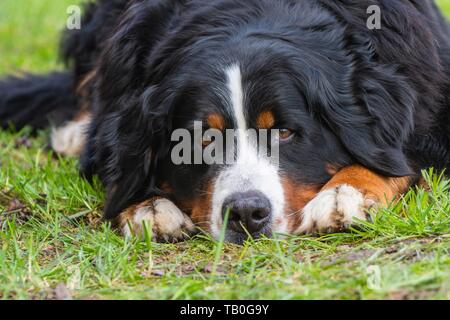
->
[120,199,195,242]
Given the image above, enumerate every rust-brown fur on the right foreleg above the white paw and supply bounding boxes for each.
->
[323,165,413,204]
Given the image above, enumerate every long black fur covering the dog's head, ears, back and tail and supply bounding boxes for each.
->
[0,0,450,229]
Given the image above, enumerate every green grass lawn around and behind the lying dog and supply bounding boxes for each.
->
[0,0,450,299]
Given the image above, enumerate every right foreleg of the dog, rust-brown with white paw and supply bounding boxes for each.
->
[296,165,413,234]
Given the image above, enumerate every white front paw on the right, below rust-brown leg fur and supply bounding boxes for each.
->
[298,184,378,233]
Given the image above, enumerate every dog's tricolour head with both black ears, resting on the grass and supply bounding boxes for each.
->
[86,1,414,242]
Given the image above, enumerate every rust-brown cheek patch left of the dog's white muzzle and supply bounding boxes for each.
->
[180,180,214,232]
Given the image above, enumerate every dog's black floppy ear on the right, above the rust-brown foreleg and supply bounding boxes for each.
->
[302,54,416,177]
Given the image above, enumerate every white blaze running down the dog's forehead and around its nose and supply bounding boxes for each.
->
[211,65,287,237]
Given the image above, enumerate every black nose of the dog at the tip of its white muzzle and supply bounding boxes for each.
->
[222,191,271,234]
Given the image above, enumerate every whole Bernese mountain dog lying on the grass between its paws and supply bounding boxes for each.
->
[0,0,450,243]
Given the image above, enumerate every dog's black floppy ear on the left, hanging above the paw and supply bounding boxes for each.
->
[91,87,170,219]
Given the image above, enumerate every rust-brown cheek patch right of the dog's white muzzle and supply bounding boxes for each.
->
[282,178,322,230]
